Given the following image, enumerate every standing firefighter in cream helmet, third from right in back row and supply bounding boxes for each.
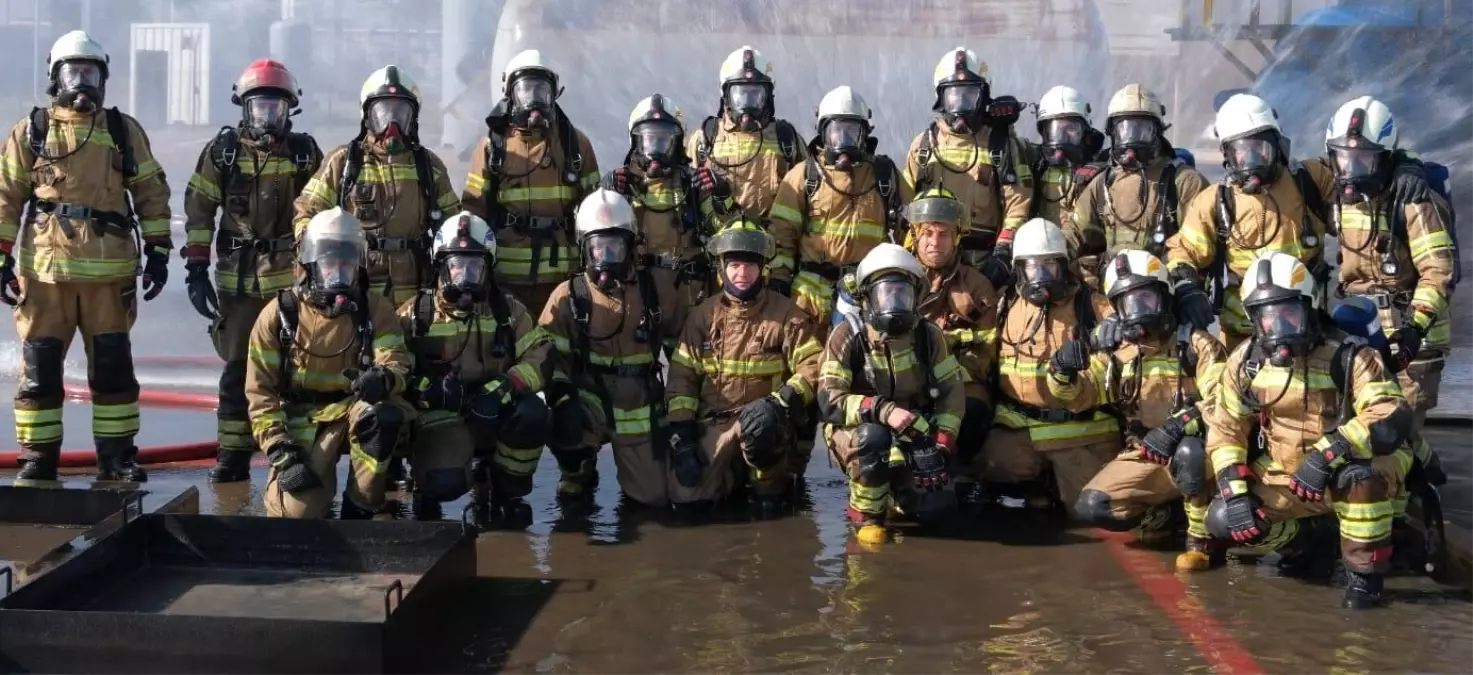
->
[1064,84,1208,293]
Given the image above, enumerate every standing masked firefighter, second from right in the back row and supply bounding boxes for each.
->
[1167,94,1332,351]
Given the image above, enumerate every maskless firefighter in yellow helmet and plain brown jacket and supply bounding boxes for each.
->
[906,187,997,506]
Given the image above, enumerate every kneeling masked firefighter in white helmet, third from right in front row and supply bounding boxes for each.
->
[982,218,1119,517]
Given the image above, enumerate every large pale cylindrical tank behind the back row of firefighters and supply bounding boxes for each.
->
[492,0,1109,165]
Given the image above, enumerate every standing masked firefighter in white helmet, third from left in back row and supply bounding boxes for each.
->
[296,65,460,307]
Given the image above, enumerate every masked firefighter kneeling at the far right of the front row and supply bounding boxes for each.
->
[1206,253,1413,609]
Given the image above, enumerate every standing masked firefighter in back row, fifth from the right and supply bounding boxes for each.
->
[906,47,1033,283]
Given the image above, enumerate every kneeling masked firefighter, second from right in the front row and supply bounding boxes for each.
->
[1074,249,1227,570]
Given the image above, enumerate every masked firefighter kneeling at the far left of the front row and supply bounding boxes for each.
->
[246,206,414,519]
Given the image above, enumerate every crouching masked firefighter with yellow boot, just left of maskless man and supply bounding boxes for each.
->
[818,243,966,545]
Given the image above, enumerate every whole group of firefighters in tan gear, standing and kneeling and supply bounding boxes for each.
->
[0,31,1455,607]
